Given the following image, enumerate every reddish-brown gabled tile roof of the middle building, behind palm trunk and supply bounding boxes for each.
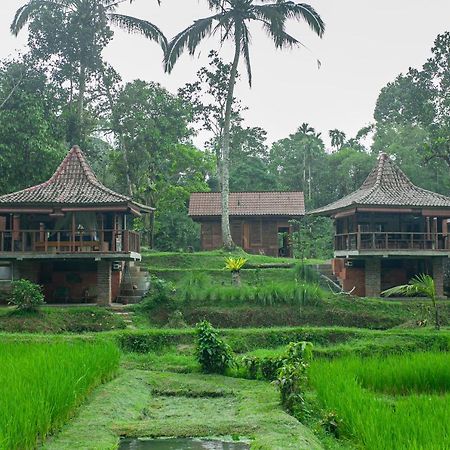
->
[189,192,305,217]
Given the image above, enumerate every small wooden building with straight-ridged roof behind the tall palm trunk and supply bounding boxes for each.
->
[189,192,305,256]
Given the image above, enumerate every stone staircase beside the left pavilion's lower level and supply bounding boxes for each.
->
[116,262,150,305]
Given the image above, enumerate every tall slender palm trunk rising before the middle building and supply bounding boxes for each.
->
[220,26,241,250]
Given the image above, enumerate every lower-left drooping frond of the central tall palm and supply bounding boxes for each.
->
[164,14,220,73]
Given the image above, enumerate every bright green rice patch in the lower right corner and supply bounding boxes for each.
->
[309,353,450,450]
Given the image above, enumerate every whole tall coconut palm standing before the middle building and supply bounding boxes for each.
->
[165,0,325,249]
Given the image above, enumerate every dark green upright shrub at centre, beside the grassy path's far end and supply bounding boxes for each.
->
[196,321,233,374]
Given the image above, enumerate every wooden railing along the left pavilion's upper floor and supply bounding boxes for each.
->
[0,230,140,253]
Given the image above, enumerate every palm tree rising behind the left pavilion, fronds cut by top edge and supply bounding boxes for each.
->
[10,0,167,141]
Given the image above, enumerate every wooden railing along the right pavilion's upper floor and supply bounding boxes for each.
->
[334,231,450,251]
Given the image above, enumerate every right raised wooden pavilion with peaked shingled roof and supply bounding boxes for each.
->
[310,153,450,297]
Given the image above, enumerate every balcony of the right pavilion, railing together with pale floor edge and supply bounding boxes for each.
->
[334,231,450,256]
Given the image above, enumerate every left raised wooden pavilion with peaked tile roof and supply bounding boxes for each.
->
[0,147,152,304]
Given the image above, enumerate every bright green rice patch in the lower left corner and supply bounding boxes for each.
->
[0,341,119,450]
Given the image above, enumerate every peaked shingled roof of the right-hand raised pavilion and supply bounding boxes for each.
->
[309,153,450,215]
